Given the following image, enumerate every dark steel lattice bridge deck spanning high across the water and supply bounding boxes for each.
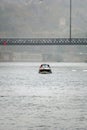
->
[0,38,87,45]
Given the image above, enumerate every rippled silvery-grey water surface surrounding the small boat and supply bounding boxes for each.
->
[0,63,87,130]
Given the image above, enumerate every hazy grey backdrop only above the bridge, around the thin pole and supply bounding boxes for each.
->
[0,0,87,38]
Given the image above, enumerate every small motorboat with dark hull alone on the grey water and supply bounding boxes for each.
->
[39,64,52,74]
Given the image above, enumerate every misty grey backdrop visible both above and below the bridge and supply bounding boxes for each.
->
[0,0,87,62]
